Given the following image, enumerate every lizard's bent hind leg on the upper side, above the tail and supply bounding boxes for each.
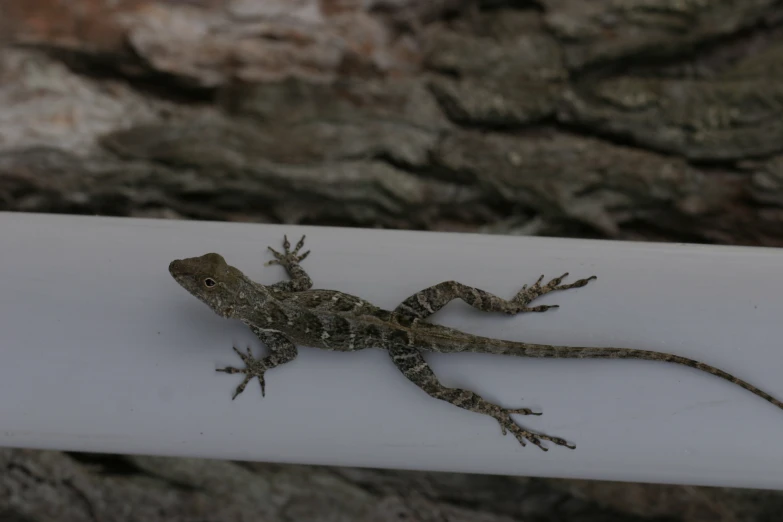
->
[394,272,596,319]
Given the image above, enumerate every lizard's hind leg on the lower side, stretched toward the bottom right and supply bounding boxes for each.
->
[389,347,576,451]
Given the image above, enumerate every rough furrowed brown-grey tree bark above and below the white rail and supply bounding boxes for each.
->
[0,0,783,522]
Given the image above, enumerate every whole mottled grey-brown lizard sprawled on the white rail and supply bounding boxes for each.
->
[169,236,783,451]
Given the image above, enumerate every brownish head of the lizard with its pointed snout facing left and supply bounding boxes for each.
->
[169,254,245,318]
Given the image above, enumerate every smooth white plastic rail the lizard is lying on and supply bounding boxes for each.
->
[0,209,783,488]
